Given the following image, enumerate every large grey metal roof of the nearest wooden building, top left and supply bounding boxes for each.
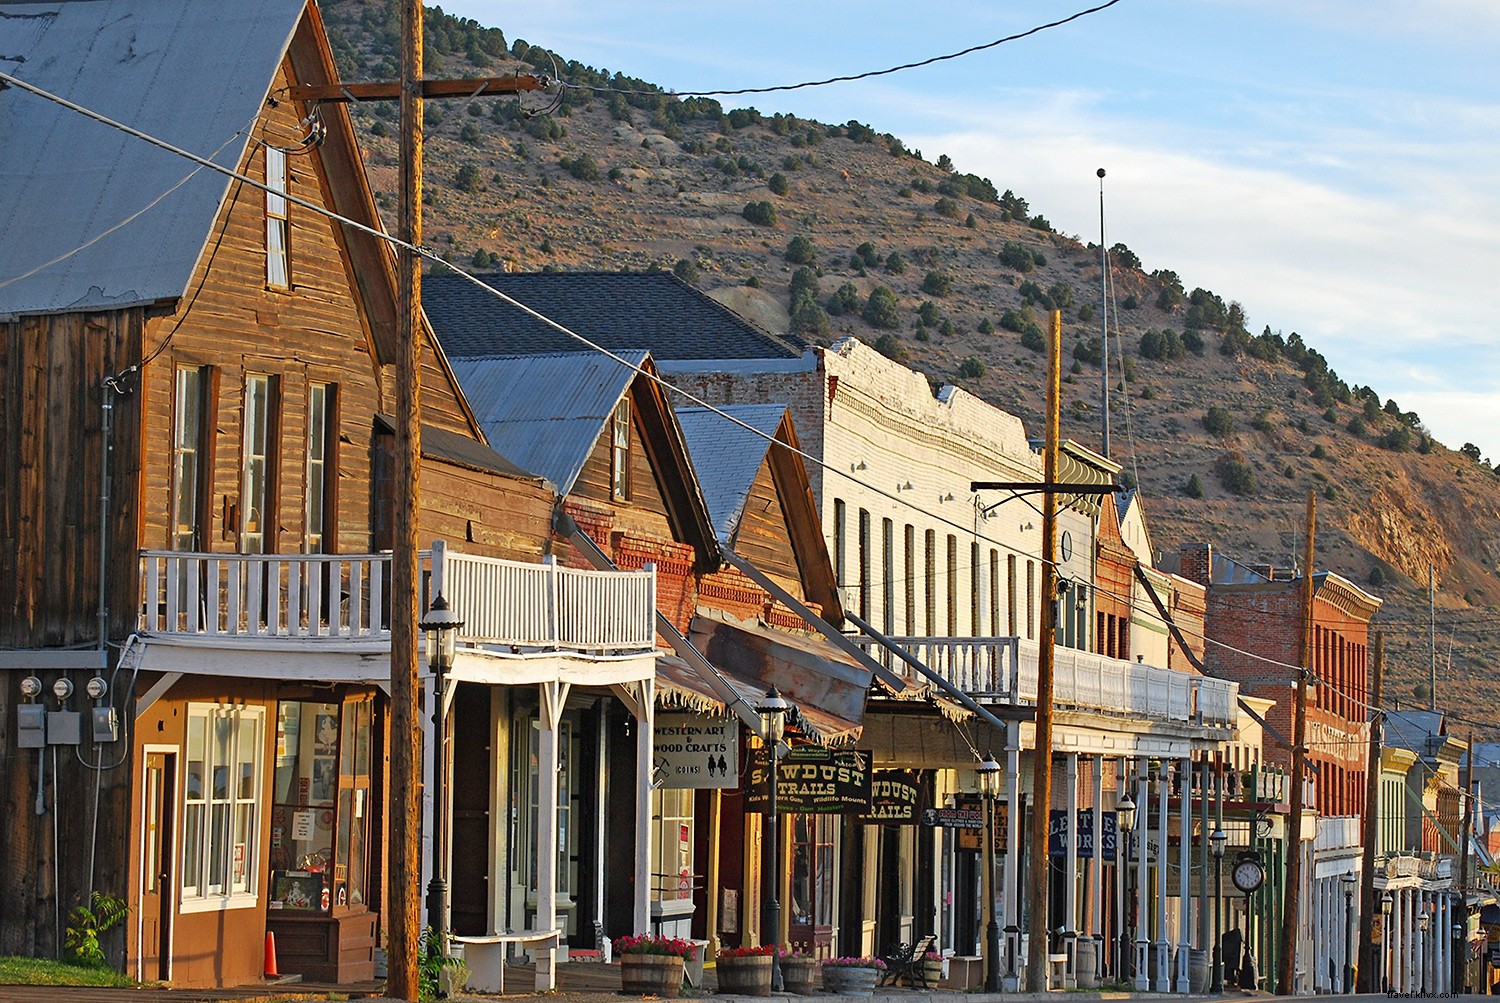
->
[0,0,305,315]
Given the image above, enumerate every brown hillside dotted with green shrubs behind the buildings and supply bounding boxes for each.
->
[324,0,1500,735]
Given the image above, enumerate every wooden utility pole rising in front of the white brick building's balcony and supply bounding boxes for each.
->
[1026,310,1077,993]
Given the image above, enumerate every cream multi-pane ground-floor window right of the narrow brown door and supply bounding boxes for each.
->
[182,703,266,912]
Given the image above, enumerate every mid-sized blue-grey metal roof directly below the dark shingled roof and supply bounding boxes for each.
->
[453,349,648,495]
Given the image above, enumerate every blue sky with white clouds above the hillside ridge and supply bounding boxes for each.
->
[444,0,1500,462]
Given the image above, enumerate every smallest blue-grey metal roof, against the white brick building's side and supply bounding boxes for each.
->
[677,403,786,544]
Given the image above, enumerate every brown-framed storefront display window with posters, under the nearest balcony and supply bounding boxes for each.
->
[270,697,374,915]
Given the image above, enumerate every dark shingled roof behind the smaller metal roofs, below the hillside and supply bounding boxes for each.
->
[422,271,804,358]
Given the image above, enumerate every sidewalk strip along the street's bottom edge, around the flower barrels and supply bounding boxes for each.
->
[0,961,1263,1003]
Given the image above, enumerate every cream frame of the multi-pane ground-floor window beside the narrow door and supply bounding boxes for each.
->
[176,703,266,913]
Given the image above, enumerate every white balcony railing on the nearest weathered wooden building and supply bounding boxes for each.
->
[138,541,656,654]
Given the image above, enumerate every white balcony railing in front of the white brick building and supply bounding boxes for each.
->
[855,637,1239,727]
